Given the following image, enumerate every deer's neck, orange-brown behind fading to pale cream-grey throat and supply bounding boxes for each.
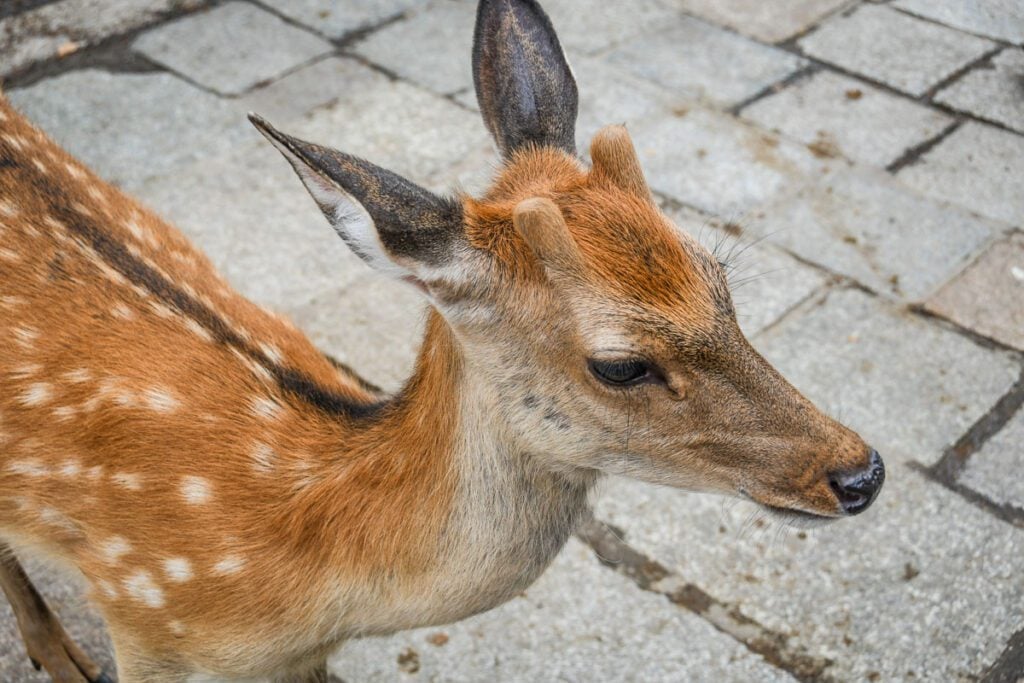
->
[296,311,595,633]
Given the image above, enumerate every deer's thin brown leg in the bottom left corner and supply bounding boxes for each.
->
[0,543,114,683]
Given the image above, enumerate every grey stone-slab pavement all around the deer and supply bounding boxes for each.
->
[0,0,1024,683]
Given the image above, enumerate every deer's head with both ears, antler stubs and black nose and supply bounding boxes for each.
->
[251,0,884,517]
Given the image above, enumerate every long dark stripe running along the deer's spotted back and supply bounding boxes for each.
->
[23,156,386,419]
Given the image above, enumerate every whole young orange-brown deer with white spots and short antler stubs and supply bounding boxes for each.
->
[0,0,884,681]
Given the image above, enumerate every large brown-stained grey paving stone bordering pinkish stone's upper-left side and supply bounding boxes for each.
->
[748,169,1006,301]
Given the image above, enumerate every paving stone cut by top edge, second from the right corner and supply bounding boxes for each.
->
[677,0,850,43]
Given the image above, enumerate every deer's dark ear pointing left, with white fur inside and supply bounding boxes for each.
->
[249,114,465,286]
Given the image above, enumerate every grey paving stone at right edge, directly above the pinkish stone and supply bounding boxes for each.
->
[899,122,1024,225]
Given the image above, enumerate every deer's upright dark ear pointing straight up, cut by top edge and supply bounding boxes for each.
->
[473,0,578,158]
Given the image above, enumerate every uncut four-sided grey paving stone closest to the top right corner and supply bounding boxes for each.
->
[799,5,995,95]
